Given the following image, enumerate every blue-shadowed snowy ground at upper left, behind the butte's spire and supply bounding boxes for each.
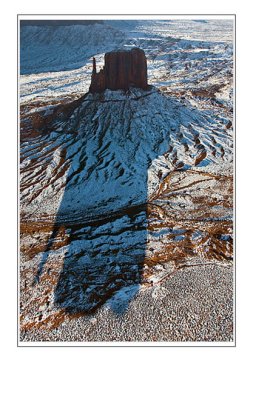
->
[20,24,125,74]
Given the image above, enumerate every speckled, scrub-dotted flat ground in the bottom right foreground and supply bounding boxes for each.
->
[21,264,233,344]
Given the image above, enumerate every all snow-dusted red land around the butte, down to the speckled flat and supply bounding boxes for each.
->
[20,20,233,340]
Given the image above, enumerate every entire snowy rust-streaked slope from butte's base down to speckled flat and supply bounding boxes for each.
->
[21,88,233,336]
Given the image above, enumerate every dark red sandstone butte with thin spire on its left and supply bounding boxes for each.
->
[90,48,148,93]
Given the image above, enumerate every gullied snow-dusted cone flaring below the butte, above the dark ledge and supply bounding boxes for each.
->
[21,88,232,222]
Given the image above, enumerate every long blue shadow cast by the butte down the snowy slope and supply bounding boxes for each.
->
[37,57,213,314]
